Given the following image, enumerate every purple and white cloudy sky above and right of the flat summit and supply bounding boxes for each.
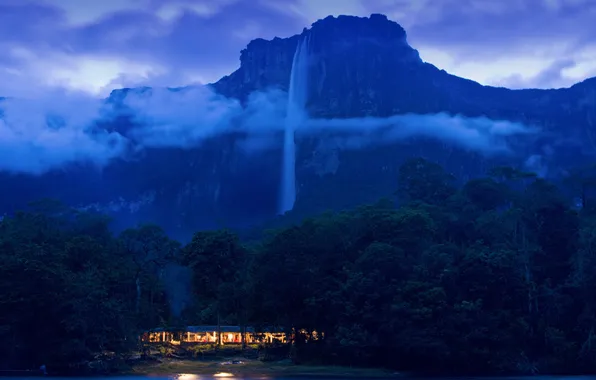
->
[269,0,596,88]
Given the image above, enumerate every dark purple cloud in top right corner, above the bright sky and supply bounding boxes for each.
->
[386,0,596,55]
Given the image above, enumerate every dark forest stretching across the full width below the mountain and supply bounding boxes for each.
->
[0,158,596,374]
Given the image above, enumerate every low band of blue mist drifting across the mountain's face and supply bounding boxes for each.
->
[0,86,536,174]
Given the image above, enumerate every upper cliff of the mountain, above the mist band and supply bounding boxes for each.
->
[215,15,596,129]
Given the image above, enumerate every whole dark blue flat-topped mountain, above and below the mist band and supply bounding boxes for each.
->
[0,14,596,239]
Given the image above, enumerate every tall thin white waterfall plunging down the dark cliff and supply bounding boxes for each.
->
[279,37,308,214]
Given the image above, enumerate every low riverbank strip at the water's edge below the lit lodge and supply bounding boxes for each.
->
[130,358,399,379]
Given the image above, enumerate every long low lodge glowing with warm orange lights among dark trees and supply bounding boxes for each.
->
[141,326,287,345]
